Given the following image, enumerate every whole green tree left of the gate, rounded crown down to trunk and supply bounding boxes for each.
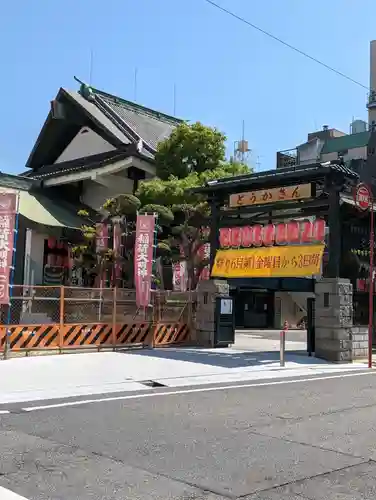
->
[137,122,250,289]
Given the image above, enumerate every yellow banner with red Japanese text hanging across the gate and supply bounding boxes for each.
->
[211,245,324,278]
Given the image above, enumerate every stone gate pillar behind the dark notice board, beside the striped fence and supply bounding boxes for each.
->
[194,279,230,347]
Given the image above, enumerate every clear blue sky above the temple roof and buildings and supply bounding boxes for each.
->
[0,0,376,173]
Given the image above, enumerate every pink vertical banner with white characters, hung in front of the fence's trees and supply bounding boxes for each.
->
[134,215,155,307]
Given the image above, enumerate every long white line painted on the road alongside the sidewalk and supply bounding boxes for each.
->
[22,371,376,412]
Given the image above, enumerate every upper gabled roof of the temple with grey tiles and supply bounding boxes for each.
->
[26,82,183,171]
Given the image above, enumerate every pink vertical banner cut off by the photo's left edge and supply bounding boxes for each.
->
[0,193,17,304]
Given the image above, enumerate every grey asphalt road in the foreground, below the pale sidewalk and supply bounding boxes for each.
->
[0,372,376,500]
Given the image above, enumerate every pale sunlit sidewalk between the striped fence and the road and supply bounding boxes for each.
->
[0,334,365,404]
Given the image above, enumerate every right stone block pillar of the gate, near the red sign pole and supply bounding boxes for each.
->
[315,278,353,363]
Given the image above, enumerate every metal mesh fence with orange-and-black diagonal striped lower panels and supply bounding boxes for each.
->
[0,286,195,351]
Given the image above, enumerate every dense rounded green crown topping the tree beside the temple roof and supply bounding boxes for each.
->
[155,122,226,181]
